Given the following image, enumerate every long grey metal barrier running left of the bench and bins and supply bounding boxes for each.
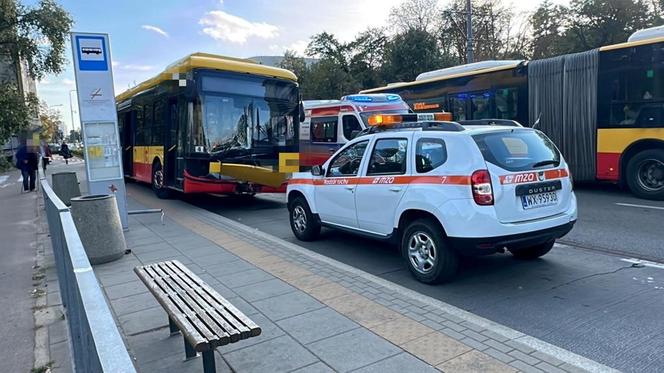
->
[40,178,136,373]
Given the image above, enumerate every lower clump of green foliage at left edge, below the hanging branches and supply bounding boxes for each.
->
[0,83,39,144]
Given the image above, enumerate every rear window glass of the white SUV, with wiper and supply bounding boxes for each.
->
[473,129,560,171]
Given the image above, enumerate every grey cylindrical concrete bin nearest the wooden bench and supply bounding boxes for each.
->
[71,195,127,264]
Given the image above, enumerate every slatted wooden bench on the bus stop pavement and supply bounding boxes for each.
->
[134,260,261,373]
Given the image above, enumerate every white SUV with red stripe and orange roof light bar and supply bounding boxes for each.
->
[287,114,577,283]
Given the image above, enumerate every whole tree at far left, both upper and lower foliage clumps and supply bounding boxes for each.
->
[0,0,72,143]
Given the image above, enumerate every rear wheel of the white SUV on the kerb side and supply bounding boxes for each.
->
[401,219,459,284]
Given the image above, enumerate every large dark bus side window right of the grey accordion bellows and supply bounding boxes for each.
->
[598,43,664,128]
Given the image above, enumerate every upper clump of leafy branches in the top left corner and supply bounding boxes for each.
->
[0,0,72,79]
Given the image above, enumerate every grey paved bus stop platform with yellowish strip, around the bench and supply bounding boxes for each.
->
[67,185,611,372]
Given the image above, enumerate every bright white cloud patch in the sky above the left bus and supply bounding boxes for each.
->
[198,10,279,44]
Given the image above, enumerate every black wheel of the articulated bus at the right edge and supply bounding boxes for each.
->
[626,149,664,201]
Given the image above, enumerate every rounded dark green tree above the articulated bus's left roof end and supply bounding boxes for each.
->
[383,29,452,82]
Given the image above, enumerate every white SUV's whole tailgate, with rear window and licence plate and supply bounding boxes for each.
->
[473,128,572,223]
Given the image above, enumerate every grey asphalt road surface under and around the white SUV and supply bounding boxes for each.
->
[184,185,664,372]
